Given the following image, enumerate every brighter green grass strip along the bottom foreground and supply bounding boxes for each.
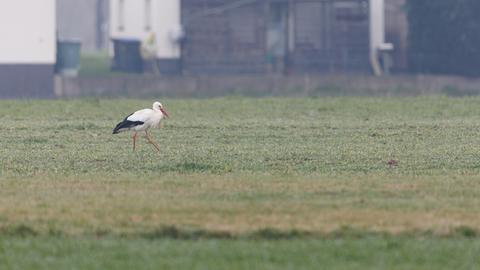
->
[0,237,480,270]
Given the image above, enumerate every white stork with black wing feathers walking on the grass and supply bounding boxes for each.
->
[113,101,168,151]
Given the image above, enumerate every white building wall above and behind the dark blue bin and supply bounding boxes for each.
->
[110,0,180,59]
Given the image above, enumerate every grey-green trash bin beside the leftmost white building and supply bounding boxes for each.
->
[55,40,81,76]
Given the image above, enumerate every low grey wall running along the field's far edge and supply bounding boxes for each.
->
[57,75,480,98]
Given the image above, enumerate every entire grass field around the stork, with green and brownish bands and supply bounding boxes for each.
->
[0,97,480,269]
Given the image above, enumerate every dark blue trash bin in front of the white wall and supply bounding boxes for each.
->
[112,39,143,73]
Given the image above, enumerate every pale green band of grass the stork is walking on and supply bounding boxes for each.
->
[0,98,480,177]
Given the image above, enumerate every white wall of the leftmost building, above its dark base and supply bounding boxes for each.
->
[0,0,56,64]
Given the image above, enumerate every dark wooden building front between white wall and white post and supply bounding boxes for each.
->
[182,0,370,74]
